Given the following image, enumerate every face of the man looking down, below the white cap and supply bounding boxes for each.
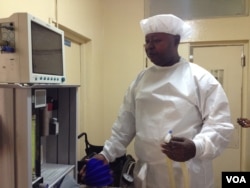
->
[145,33,180,66]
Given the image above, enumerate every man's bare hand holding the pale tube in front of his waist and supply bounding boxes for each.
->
[161,137,196,162]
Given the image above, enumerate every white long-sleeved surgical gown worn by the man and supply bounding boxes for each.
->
[102,58,234,188]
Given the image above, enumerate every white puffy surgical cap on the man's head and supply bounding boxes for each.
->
[140,14,191,40]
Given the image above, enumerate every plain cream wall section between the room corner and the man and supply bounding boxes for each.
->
[100,0,144,156]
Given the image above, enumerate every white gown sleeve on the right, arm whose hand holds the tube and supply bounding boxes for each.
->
[193,70,234,159]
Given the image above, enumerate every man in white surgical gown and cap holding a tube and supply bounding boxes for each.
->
[95,14,234,188]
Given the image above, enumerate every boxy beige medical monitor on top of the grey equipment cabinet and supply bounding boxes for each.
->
[0,13,65,84]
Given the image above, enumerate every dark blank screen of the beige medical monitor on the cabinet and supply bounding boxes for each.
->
[31,21,63,75]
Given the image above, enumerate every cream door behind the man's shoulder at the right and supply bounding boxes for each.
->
[191,44,244,188]
